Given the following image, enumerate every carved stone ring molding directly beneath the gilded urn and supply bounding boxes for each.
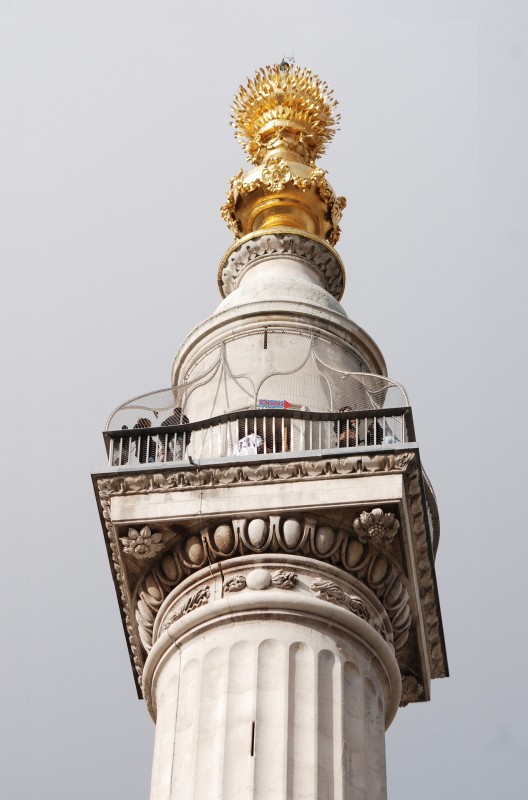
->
[218,233,344,300]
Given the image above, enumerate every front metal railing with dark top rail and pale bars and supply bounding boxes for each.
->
[105,407,415,467]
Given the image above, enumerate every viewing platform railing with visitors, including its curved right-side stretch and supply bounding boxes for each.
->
[104,405,440,552]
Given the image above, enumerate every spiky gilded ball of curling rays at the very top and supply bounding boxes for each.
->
[231,65,340,164]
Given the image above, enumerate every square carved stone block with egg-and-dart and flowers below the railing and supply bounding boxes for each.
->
[95,451,446,699]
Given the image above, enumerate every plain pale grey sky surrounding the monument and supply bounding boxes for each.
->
[0,0,528,800]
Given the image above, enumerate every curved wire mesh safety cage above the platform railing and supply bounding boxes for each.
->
[106,327,409,431]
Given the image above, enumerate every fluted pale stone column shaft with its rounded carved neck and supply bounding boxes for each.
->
[143,555,401,800]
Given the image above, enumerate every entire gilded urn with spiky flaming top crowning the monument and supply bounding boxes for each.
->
[221,62,346,244]
